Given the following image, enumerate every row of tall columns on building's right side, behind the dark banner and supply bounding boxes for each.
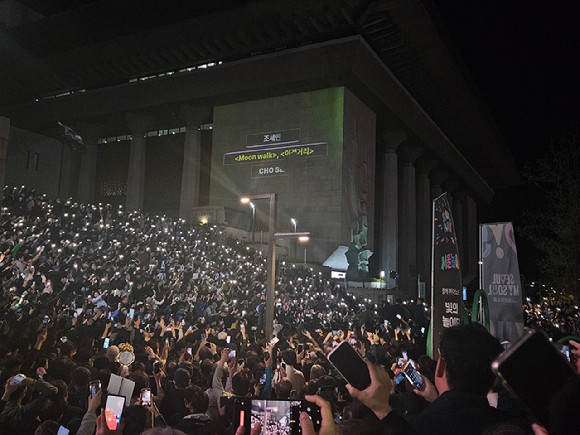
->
[380,131,478,298]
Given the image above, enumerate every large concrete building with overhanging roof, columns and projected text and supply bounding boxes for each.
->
[0,0,519,295]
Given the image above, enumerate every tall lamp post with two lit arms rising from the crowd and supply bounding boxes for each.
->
[240,193,310,341]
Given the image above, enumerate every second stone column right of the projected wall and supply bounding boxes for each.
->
[398,143,423,298]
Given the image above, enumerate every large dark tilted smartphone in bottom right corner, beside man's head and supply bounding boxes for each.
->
[492,329,580,433]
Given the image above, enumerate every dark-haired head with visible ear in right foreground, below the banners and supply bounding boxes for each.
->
[435,323,503,396]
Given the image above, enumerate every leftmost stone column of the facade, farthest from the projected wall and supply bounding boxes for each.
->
[75,123,103,204]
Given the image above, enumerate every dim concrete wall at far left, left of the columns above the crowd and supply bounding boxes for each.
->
[5,127,62,198]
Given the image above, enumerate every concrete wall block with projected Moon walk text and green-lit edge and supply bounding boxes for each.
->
[210,87,375,263]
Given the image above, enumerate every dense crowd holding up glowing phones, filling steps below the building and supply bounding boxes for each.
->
[0,188,580,435]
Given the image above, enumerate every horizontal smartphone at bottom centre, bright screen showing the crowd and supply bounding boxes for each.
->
[233,397,322,435]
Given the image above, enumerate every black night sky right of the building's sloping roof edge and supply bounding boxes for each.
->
[433,0,580,279]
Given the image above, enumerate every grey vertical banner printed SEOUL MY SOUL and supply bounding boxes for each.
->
[480,222,524,342]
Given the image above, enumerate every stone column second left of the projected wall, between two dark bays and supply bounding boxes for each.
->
[125,113,154,211]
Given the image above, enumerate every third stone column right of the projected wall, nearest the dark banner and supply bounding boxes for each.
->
[415,158,437,300]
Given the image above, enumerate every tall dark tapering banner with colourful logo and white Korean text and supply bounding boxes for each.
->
[427,193,463,359]
